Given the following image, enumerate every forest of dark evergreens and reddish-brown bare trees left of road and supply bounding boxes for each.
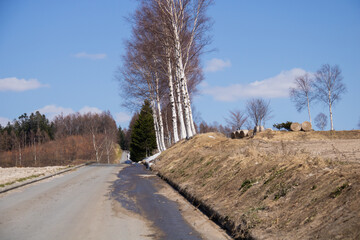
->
[0,112,118,167]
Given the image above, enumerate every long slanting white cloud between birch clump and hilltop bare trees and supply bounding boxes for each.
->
[202,68,306,102]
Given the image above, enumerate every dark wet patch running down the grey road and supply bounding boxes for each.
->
[111,164,202,240]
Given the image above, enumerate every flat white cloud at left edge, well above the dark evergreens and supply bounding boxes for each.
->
[0,77,49,92]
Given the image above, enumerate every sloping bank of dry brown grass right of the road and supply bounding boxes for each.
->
[153,131,360,239]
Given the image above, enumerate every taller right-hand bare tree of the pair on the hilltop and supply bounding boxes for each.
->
[314,64,346,130]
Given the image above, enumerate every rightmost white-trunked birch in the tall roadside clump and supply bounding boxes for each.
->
[154,0,211,137]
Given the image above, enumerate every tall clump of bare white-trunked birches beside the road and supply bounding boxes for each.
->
[118,0,211,151]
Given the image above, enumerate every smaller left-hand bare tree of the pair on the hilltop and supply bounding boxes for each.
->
[290,73,314,123]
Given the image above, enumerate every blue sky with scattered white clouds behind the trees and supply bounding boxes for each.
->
[0,0,360,130]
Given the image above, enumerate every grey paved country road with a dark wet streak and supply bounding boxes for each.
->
[0,160,230,240]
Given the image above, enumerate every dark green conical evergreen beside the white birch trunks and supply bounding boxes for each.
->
[130,100,157,162]
